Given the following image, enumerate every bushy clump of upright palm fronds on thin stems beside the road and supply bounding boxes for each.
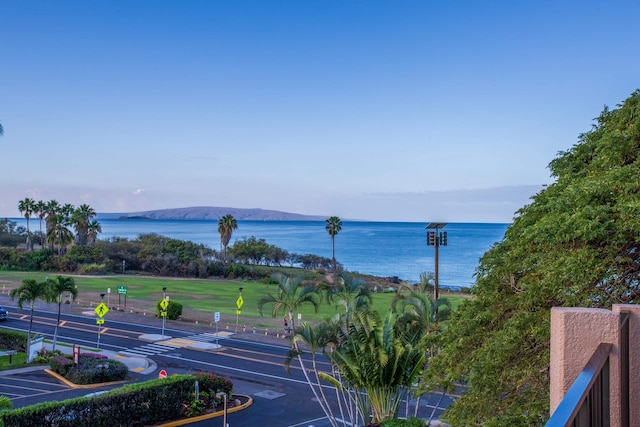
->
[285,311,426,427]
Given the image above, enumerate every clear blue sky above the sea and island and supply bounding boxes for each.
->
[0,0,640,222]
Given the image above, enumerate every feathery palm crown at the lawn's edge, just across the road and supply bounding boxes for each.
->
[258,273,320,329]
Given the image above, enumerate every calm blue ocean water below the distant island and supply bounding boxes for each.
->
[8,216,508,289]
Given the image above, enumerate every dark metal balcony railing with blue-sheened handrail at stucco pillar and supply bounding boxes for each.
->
[545,312,629,427]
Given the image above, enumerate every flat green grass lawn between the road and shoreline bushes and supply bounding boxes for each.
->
[0,271,465,327]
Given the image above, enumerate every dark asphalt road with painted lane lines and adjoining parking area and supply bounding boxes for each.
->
[0,296,451,427]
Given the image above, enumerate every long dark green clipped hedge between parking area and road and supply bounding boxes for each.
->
[0,373,233,427]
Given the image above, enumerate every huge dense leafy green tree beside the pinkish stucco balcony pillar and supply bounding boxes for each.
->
[425,91,640,426]
